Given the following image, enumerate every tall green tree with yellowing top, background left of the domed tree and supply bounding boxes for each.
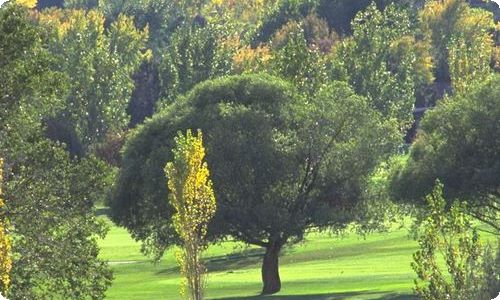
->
[40,10,148,156]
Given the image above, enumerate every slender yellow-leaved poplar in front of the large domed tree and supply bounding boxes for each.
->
[165,130,216,300]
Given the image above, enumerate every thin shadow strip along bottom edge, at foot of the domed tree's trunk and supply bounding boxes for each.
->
[209,291,418,300]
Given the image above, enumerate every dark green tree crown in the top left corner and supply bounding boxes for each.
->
[0,3,63,157]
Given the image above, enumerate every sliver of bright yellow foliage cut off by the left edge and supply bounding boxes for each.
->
[0,158,12,295]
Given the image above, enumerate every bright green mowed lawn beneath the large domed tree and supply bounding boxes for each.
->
[96,217,417,300]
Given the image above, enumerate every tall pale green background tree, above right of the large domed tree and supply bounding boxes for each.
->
[337,4,431,132]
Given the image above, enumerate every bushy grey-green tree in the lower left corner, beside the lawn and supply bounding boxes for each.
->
[5,140,112,299]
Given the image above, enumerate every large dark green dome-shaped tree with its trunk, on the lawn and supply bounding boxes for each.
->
[111,74,401,294]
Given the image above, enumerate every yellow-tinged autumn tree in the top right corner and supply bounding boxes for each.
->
[420,0,494,89]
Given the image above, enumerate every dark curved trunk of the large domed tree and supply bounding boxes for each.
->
[262,242,282,295]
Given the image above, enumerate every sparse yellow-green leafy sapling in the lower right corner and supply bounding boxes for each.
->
[412,182,500,300]
